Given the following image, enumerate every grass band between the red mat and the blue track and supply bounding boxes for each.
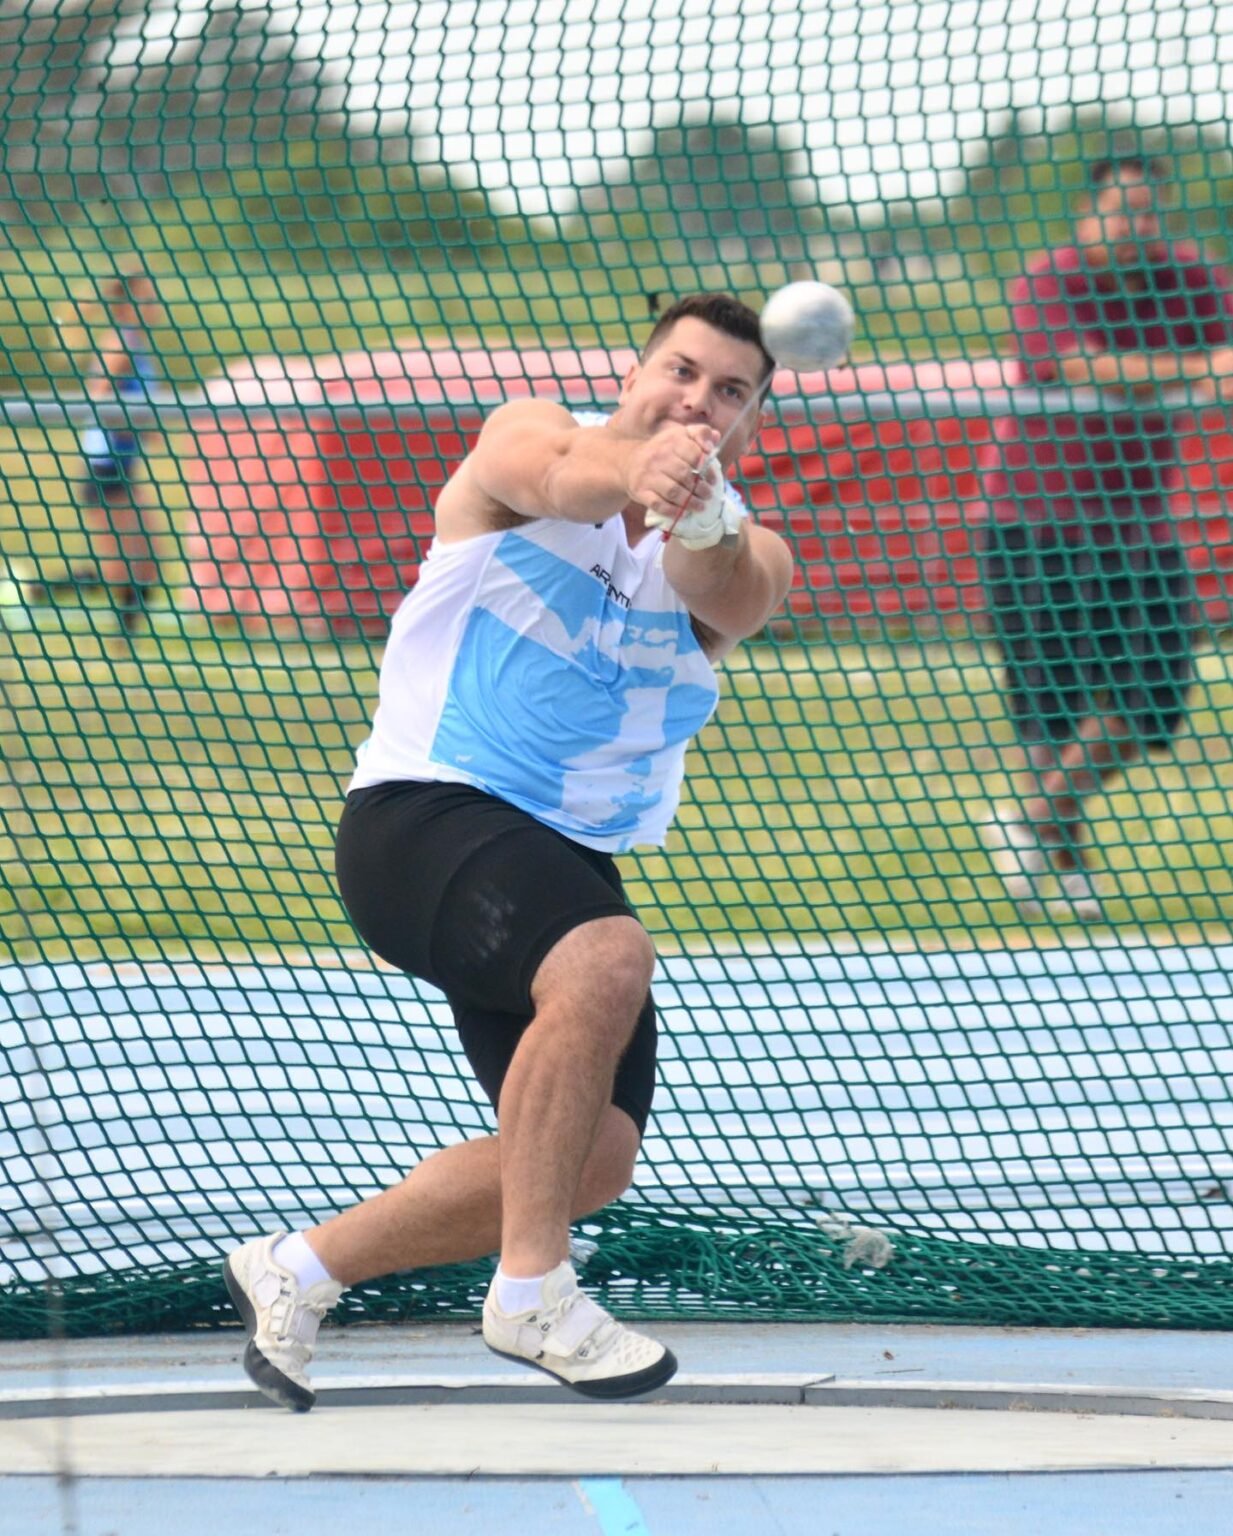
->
[0,582,1233,960]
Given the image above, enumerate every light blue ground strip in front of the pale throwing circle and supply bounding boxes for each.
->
[0,1471,1233,1536]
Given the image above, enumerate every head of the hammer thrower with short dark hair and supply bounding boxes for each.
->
[620,315,763,468]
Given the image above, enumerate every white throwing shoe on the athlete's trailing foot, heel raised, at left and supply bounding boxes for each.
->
[223,1232,342,1413]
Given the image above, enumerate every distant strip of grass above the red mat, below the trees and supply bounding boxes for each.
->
[0,235,1009,395]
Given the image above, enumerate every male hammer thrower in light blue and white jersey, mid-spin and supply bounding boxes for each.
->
[226,295,792,1410]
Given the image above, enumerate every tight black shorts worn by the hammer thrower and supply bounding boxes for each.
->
[335,782,656,1135]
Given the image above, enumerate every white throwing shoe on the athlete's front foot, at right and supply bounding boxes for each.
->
[484,1261,677,1398]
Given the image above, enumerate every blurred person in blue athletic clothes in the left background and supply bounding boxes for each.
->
[31,270,166,631]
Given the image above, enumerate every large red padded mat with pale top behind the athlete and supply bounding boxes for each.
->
[186,349,1233,634]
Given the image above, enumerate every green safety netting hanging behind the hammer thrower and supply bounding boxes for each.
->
[0,0,1233,1336]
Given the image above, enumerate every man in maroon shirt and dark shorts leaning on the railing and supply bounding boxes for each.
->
[981,160,1233,922]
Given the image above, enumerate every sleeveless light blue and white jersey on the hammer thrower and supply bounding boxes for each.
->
[350,418,733,852]
